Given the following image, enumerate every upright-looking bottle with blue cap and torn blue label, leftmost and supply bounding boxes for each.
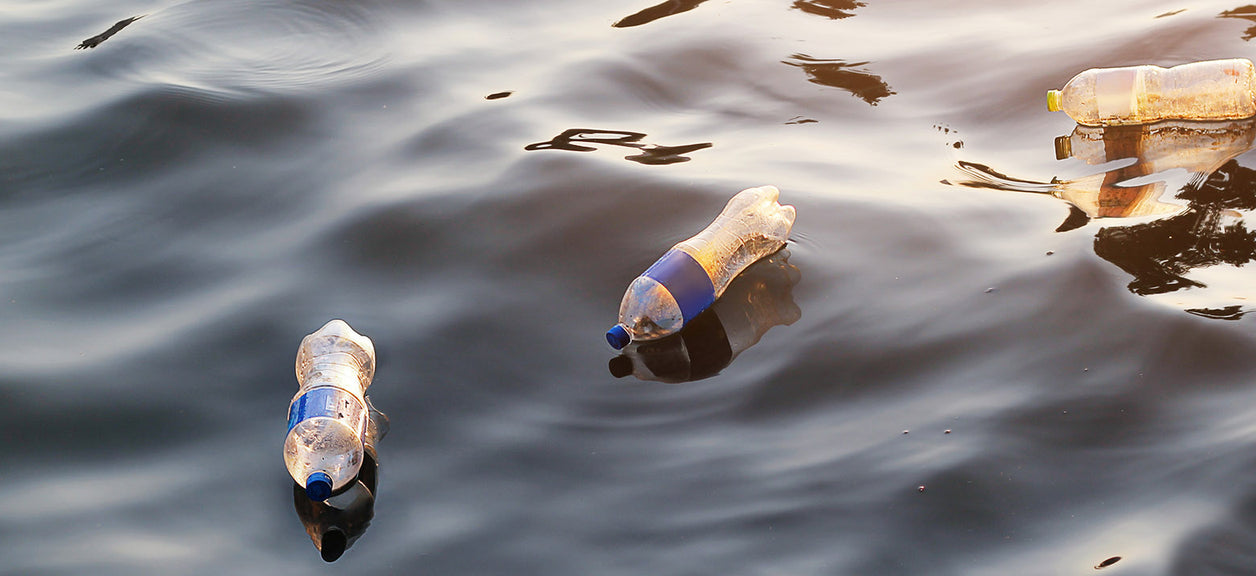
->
[284,320,376,501]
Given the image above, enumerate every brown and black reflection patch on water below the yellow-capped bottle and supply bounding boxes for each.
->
[955,120,1256,319]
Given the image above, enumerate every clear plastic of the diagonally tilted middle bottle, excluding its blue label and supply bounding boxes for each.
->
[612,186,795,348]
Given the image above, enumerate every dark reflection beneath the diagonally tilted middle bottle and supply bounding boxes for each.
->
[609,248,803,383]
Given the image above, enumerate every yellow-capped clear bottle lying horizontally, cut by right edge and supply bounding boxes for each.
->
[1046,58,1256,125]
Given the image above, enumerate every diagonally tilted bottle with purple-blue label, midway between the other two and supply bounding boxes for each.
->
[607,186,795,350]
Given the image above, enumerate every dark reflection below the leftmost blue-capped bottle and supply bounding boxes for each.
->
[293,397,388,562]
